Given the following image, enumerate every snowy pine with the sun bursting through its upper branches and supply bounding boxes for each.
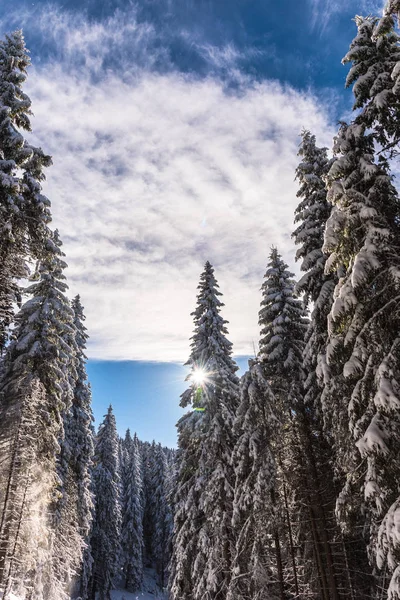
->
[170,262,239,600]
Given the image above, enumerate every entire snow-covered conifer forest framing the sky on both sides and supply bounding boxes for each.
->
[0,0,400,600]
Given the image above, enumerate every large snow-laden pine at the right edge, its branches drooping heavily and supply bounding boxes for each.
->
[324,123,400,598]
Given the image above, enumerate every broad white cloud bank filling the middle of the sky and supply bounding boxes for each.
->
[28,67,332,360]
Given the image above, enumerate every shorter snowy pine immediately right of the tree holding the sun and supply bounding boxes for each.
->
[227,361,280,600]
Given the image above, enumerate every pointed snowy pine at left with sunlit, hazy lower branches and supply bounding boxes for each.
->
[0,233,75,598]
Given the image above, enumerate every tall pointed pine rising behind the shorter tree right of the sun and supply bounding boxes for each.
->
[259,248,308,599]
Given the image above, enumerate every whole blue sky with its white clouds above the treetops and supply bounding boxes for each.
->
[0,0,383,445]
